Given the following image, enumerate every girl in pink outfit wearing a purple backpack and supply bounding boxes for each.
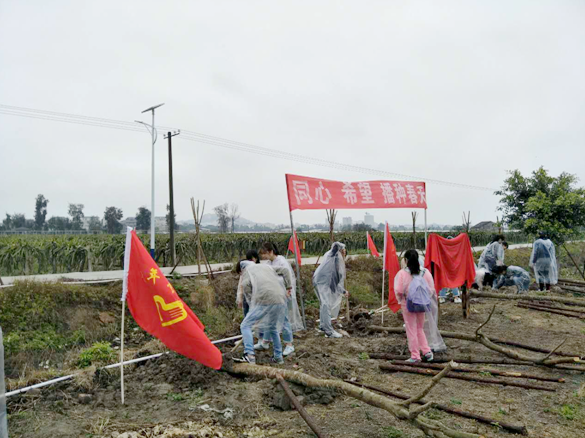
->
[394,249,435,362]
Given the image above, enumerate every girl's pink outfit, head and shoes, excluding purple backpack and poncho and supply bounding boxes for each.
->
[394,249,435,362]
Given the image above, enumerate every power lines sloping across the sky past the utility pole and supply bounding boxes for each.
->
[0,104,495,192]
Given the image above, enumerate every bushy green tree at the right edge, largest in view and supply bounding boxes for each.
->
[496,167,585,244]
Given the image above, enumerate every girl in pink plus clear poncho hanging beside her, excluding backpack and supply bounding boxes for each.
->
[394,249,447,362]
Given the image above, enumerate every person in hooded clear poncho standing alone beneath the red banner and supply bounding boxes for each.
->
[313,242,348,338]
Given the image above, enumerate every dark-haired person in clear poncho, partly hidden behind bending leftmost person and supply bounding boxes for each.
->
[254,242,304,357]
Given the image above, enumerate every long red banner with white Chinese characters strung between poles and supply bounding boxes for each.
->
[286,174,427,211]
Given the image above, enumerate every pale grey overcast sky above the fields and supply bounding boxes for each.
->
[0,0,585,229]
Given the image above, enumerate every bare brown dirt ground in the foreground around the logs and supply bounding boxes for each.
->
[8,288,585,438]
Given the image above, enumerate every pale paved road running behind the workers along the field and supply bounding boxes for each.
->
[0,243,532,287]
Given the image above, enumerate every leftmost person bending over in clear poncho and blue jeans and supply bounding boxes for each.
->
[240,264,292,364]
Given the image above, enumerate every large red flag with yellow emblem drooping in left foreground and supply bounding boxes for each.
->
[122,230,222,370]
